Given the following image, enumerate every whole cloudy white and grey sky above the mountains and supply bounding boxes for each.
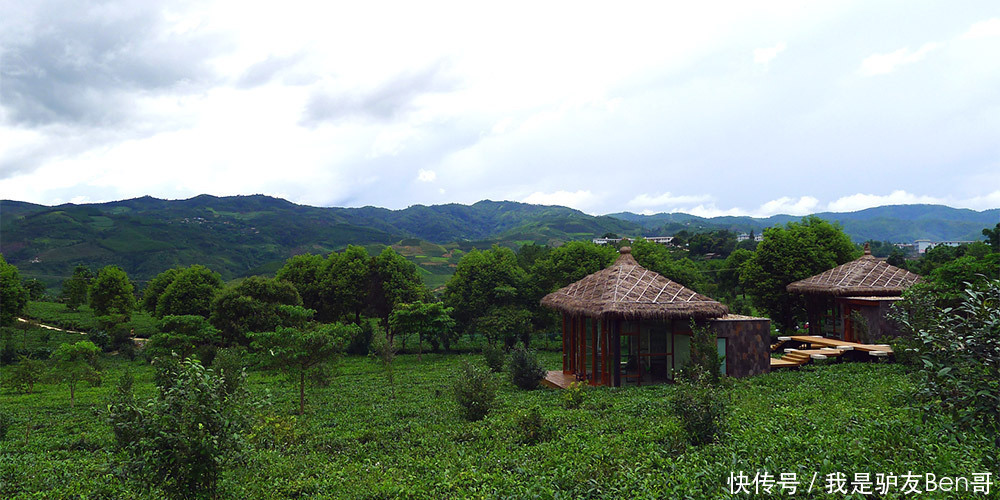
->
[0,0,1000,216]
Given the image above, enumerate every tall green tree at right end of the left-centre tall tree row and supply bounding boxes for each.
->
[368,247,427,326]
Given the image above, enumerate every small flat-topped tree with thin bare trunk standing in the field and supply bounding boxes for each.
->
[250,324,360,415]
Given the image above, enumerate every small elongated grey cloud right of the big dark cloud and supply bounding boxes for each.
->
[301,63,456,125]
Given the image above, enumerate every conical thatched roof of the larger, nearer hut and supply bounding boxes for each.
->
[542,247,729,319]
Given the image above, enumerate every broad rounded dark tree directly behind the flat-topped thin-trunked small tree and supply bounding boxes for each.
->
[211,276,313,345]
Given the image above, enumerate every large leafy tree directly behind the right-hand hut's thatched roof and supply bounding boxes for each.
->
[740,216,858,332]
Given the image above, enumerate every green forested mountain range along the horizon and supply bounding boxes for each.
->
[0,195,1000,288]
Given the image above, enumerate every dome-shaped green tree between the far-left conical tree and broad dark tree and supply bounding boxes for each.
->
[153,265,222,318]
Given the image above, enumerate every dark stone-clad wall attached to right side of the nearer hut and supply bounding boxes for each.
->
[709,317,771,377]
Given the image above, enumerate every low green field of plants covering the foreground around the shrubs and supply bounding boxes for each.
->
[0,352,990,499]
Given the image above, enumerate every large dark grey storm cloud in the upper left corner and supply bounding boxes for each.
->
[0,1,223,127]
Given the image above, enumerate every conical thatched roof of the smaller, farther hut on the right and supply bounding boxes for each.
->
[786,244,921,297]
